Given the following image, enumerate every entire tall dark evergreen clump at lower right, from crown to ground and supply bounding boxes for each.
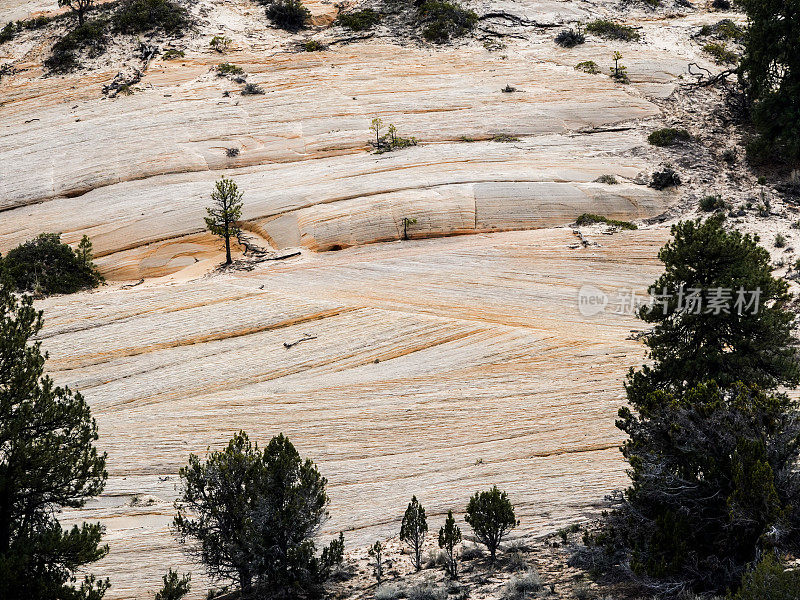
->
[576,217,800,595]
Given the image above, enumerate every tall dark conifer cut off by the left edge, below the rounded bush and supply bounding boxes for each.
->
[0,277,108,600]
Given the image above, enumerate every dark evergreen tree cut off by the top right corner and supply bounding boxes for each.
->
[740,0,800,163]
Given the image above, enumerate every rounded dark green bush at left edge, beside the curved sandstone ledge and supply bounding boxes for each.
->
[2,233,103,295]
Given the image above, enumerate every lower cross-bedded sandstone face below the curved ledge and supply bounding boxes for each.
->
[39,229,666,598]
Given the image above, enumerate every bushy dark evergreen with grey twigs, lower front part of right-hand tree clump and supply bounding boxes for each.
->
[609,381,800,593]
